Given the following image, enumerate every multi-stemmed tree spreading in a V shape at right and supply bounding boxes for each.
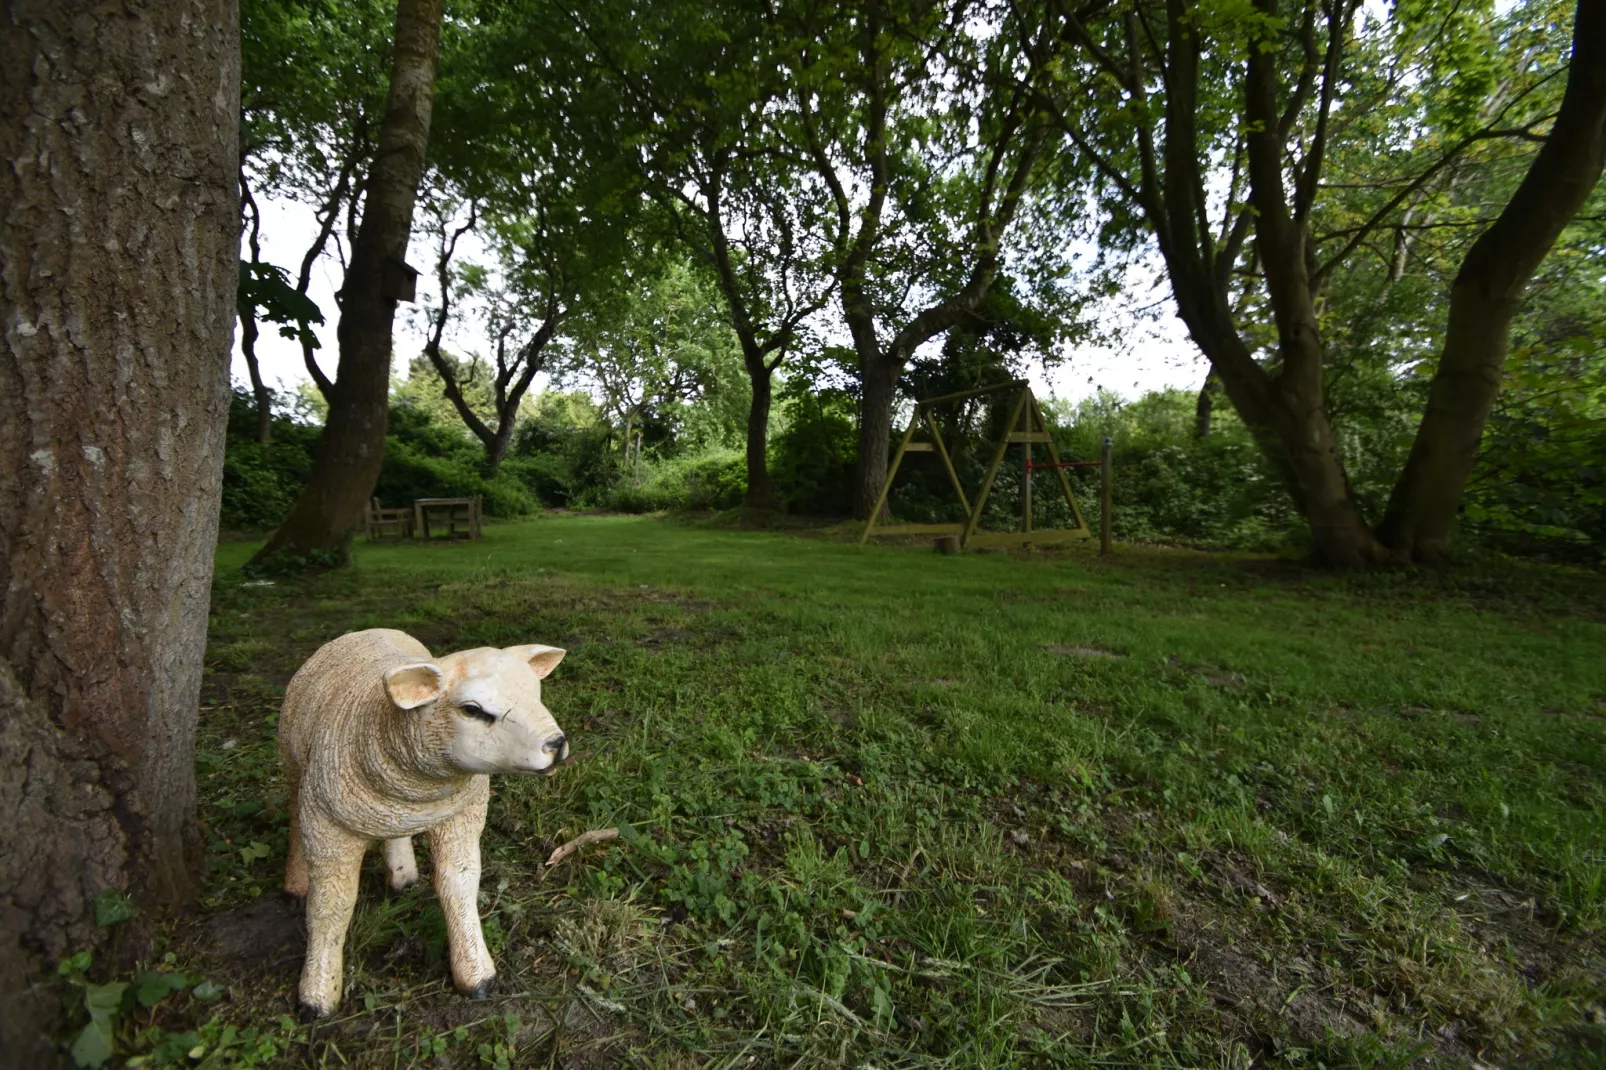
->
[1021,0,1606,566]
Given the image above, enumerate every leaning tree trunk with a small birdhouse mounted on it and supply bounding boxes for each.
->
[251,0,442,566]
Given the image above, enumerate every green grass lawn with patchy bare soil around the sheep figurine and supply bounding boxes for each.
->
[84,517,1606,1067]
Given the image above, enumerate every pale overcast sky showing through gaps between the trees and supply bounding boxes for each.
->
[234,196,1206,402]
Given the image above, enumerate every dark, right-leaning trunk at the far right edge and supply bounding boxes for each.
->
[1378,0,1606,562]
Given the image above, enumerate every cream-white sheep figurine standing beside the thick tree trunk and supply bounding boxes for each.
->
[279,628,569,1017]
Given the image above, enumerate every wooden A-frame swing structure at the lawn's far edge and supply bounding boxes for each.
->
[859,379,1099,549]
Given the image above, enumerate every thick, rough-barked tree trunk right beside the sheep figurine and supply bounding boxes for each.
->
[0,0,239,1067]
